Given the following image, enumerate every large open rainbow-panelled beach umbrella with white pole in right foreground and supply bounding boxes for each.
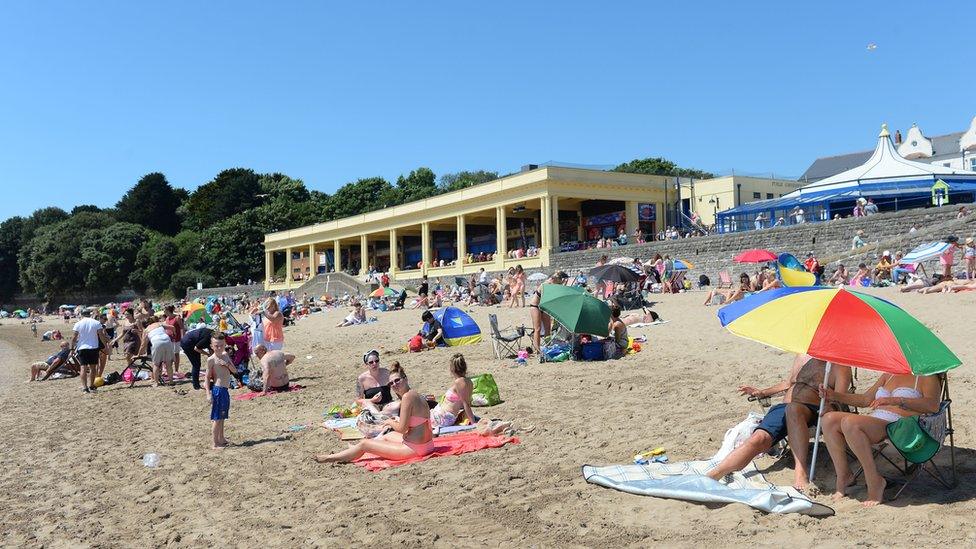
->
[718,286,962,482]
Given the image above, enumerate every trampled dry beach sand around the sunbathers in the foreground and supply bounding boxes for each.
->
[0,289,976,547]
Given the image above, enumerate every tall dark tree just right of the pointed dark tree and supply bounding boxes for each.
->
[183,168,262,231]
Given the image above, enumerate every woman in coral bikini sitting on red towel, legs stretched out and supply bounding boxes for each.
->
[315,366,434,463]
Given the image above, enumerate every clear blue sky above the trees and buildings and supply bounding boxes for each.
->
[0,0,976,219]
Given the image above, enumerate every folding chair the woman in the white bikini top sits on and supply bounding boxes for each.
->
[854,374,959,501]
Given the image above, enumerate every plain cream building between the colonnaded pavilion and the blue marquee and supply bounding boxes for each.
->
[678,175,803,227]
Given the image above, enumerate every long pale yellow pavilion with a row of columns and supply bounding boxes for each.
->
[264,167,675,289]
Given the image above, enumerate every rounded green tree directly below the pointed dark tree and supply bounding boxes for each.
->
[79,223,147,293]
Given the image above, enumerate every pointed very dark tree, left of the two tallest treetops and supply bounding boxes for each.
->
[115,172,181,235]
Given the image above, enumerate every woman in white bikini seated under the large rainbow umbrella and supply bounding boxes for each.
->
[820,374,941,507]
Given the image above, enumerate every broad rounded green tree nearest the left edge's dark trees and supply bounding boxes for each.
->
[18,212,115,296]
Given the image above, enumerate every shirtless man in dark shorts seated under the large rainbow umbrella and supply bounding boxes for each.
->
[708,355,851,491]
